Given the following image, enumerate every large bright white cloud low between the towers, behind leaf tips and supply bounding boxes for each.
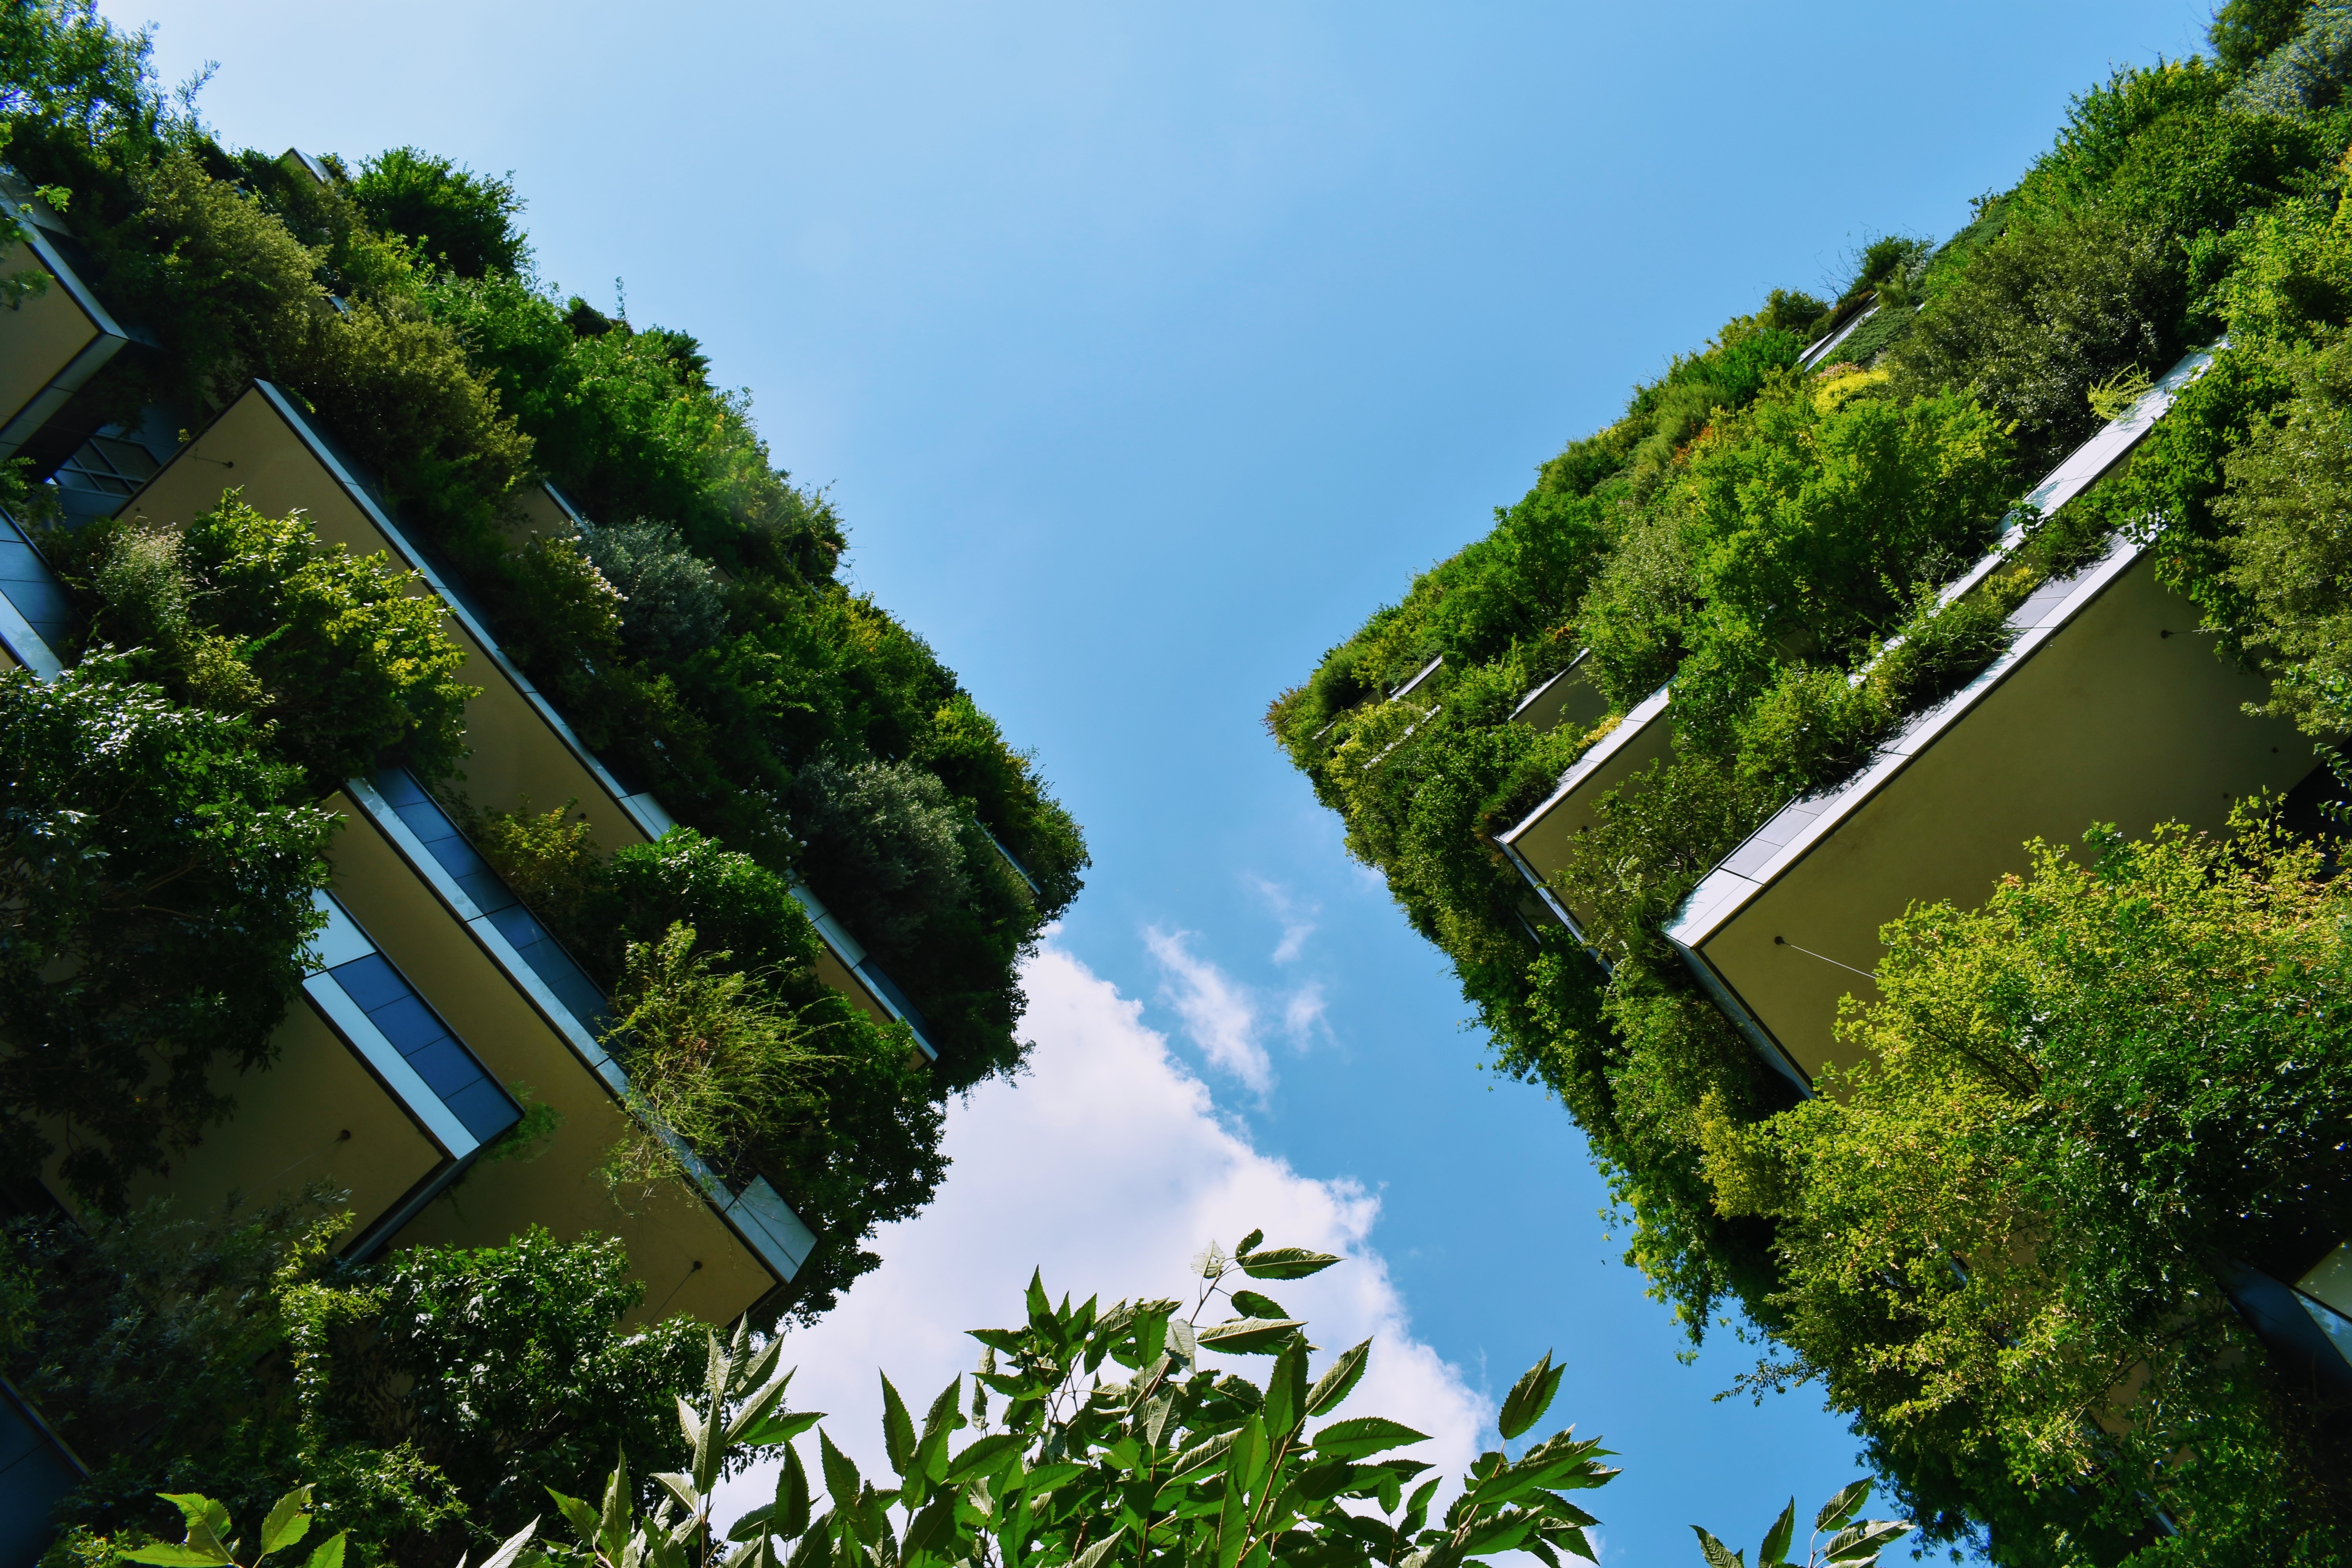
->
[720,938,1494,1519]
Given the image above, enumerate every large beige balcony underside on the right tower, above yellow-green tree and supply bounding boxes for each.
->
[1700,557,2314,1074]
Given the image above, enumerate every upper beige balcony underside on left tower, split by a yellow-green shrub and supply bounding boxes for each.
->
[127,390,644,851]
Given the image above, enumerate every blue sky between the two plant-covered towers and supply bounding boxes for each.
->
[129,0,2206,1561]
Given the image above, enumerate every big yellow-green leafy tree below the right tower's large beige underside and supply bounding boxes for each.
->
[1708,818,2352,1563]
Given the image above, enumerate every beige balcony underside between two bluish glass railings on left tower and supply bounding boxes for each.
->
[329,795,776,1323]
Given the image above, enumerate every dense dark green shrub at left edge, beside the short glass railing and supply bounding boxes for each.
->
[0,658,336,1208]
